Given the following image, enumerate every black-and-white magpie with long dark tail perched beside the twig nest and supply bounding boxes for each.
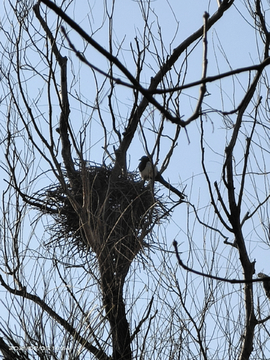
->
[138,155,185,201]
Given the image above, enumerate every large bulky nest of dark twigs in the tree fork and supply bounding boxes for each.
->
[43,166,164,272]
